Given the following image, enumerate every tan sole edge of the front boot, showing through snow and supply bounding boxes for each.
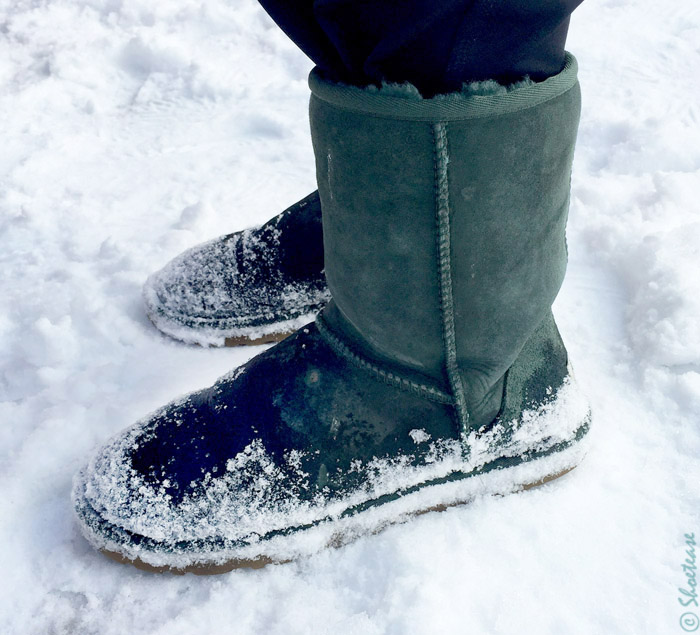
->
[100,466,576,575]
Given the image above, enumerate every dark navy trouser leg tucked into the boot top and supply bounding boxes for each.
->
[260,0,583,96]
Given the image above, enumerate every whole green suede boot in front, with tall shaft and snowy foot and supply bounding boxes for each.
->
[73,56,590,573]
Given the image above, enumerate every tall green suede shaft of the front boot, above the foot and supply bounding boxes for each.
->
[310,56,580,430]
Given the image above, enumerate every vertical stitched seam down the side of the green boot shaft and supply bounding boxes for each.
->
[433,122,469,435]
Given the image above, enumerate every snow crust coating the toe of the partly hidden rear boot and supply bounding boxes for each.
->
[143,227,330,346]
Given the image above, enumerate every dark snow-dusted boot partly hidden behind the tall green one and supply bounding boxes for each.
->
[143,192,330,346]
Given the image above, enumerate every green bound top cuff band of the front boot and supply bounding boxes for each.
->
[309,52,578,121]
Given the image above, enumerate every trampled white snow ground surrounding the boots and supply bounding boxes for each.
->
[0,0,700,635]
